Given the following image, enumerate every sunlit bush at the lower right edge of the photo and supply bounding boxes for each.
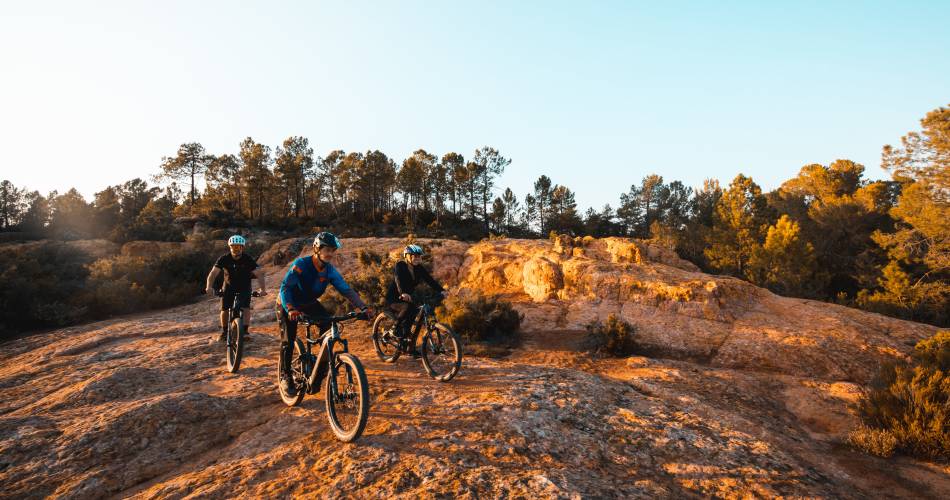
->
[860,331,950,459]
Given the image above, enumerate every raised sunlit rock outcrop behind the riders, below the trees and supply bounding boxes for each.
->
[253,236,936,382]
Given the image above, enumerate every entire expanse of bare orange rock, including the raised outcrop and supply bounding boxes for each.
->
[0,239,950,498]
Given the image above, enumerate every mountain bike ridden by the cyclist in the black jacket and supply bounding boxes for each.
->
[373,303,462,382]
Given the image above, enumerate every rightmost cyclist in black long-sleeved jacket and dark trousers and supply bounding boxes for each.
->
[386,245,447,358]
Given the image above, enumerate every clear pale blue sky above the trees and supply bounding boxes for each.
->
[0,1,950,208]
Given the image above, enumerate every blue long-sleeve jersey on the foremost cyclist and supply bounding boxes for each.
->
[277,256,366,312]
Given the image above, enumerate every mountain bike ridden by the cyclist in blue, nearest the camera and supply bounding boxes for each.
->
[277,311,369,442]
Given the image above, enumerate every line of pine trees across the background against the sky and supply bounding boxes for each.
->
[0,103,950,324]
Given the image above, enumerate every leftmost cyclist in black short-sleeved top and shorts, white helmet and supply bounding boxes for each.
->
[205,234,267,342]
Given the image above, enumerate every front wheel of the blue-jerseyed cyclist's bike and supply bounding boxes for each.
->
[324,353,369,443]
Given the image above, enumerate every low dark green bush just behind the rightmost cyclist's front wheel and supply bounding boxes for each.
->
[436,294,523,342]
